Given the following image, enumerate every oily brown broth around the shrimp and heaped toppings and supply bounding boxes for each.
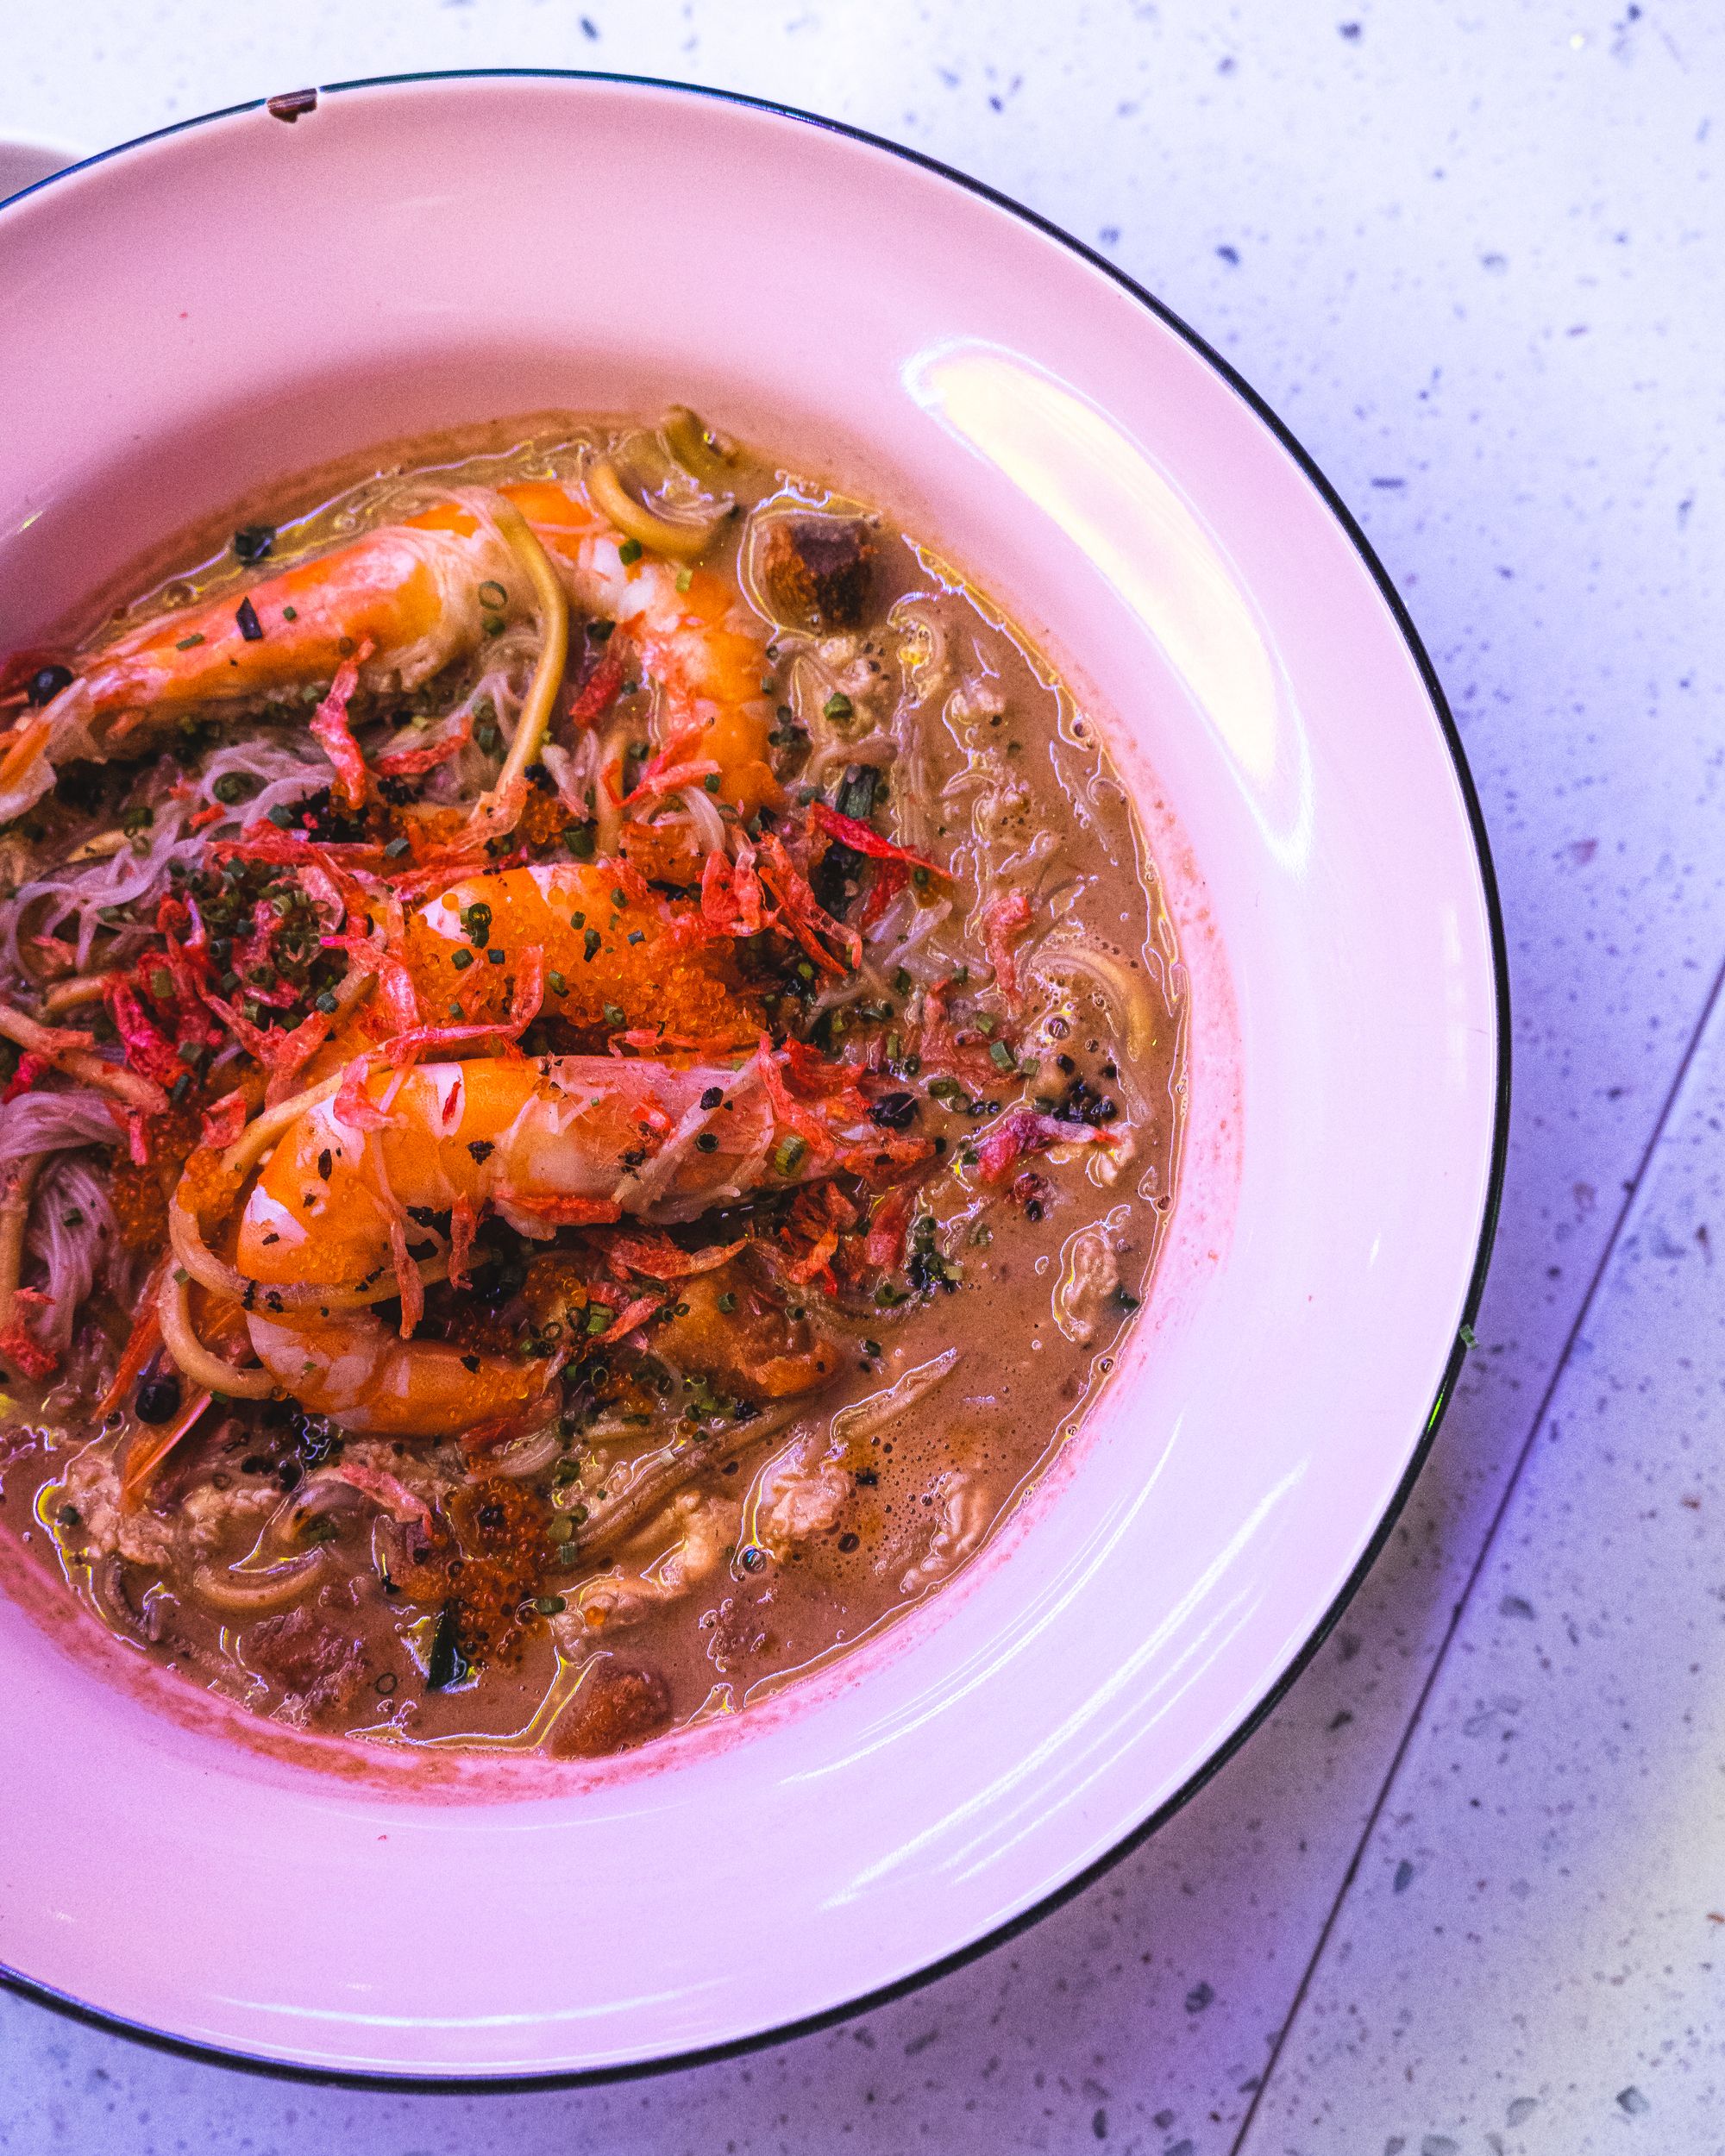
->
[0,418,1184,1751]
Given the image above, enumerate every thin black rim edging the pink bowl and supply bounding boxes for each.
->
[0,67,1509,2096]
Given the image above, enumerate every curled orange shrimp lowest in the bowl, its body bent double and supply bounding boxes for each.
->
[237,1052,880,1436]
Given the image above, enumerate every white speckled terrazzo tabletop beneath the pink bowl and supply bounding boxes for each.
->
[0,0,1725,2156]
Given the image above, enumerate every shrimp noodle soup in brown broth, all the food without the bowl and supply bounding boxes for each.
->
[0,412,1184,1755]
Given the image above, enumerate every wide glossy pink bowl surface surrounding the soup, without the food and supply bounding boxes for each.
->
[0,76,1505,2081]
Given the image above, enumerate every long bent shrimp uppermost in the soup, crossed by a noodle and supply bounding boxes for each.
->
[0,481,781,819]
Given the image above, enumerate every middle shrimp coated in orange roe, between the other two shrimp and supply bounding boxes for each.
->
[408,861,759,1048]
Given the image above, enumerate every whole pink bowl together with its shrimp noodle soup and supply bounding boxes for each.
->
[0,76,1505,2083]
